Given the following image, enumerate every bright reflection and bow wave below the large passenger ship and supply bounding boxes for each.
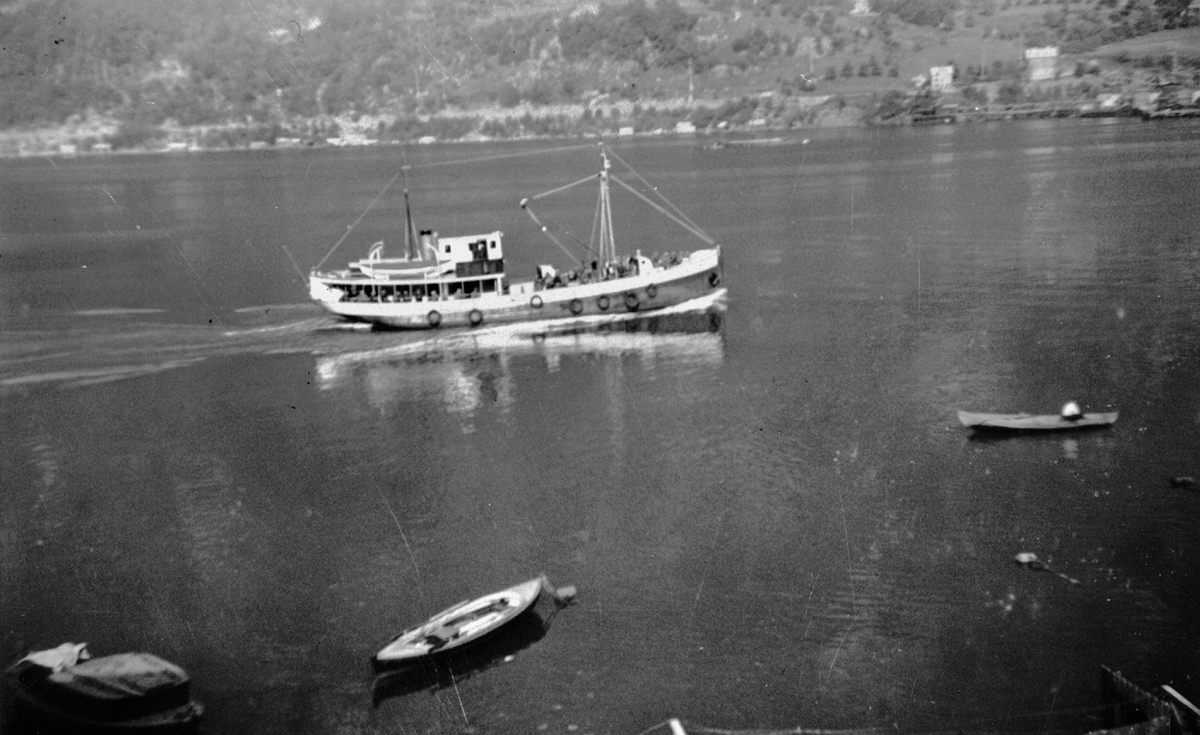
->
[317,294,725,417]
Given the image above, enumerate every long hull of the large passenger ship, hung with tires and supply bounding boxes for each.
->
[310,247,722,329]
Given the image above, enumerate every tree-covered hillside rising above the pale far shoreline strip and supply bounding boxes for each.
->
[0,0,1198,140]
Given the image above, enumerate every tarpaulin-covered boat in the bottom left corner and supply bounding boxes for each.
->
[0,643,204,735]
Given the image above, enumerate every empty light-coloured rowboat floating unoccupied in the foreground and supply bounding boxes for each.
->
[371,576,553,670]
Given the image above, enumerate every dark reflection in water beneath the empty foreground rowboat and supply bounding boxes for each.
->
[371,606,549,707]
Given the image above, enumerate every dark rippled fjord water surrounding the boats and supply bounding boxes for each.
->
[0,121,1200,734]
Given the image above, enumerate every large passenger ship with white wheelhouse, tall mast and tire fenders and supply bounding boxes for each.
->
[308,145,724,329]
